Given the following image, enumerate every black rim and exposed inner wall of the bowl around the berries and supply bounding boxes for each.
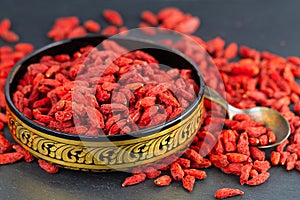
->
[5,36,204,141]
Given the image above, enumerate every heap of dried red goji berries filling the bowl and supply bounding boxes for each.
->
[13,40,199,136]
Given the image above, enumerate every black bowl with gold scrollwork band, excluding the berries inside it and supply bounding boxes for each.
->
[5,35,204,172]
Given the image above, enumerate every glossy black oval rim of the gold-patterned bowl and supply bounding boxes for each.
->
[5,35,205,142]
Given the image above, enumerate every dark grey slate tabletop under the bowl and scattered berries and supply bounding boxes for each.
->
[0,0,300,200]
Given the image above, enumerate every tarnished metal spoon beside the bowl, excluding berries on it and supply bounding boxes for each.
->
[204,86,290,148]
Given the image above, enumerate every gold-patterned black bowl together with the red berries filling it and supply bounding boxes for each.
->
[5,36,205,171]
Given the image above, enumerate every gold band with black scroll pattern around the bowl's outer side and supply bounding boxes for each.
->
[7,98,203,171]
